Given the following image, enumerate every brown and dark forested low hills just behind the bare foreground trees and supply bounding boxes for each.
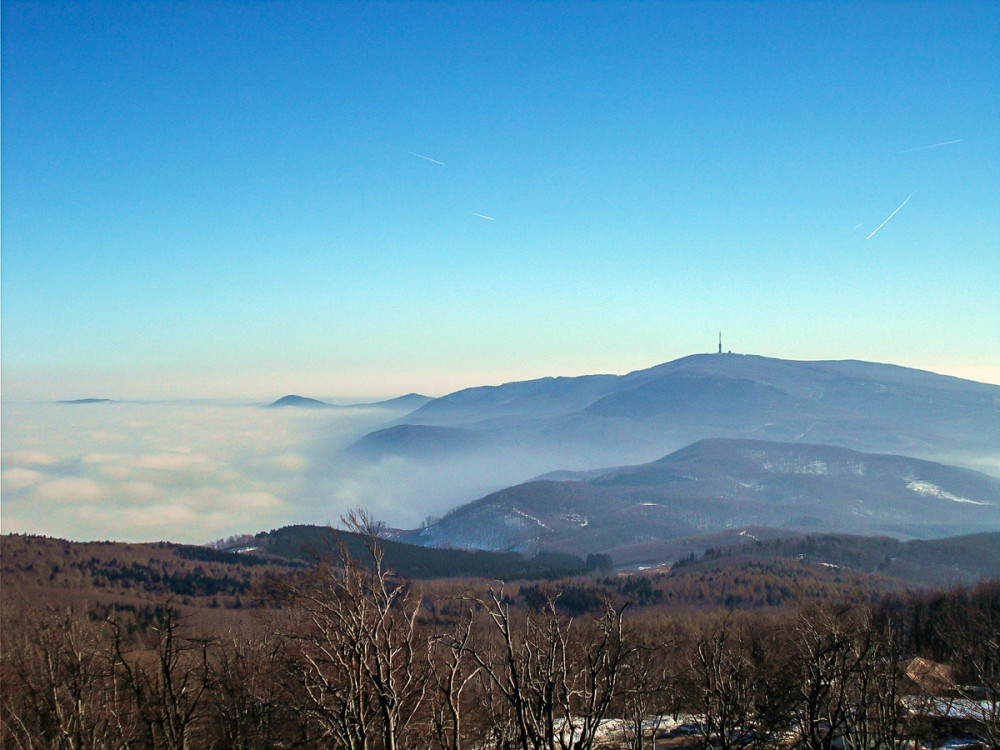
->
[7,526,1000,625]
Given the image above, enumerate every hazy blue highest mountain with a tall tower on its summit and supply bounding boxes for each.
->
[351,354,1000,488]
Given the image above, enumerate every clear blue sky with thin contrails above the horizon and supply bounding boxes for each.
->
[0,0,1000,401]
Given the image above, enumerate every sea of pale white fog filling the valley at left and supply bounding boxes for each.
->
[0,402,524,543]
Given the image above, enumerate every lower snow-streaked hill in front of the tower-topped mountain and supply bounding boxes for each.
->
[401,438,1000,558]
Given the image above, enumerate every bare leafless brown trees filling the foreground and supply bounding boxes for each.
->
[0,513,1000,750]
